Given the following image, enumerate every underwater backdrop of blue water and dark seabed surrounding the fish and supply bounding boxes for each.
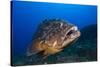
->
[11,1,97,65]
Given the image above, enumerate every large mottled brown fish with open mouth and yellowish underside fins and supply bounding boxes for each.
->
[27,19,80,56]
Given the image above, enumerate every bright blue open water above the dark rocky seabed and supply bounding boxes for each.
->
[11,1,97,56]
